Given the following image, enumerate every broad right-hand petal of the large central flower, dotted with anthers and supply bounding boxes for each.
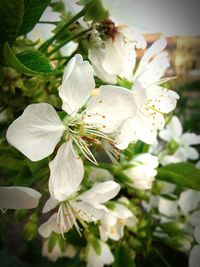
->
[84,85,136,133]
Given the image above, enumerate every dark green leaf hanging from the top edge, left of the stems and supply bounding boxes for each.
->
[17,0,51,36]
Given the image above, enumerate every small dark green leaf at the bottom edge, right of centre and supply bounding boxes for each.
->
[112,246,136,267]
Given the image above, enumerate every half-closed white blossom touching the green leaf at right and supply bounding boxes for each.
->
[124,153,158,190]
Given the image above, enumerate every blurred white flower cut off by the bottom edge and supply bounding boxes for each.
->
[87,240,114,267]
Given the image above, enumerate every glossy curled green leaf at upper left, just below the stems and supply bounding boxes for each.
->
[3,43,55,75]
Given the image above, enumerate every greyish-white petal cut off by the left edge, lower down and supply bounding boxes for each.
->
[0,186,41,209]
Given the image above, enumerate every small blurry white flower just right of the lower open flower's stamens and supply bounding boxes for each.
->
[99,203,137,241]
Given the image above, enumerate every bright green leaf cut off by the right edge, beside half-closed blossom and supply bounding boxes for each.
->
[156,163,200,191]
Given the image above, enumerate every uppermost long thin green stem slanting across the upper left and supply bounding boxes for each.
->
[39,9,85,51]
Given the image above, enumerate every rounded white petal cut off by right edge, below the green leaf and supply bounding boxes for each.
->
[178,189,200,212]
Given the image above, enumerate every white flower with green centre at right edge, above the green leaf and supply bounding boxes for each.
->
[159,116,200,165]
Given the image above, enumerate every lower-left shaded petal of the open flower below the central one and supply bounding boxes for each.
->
[38,212,61,238]
